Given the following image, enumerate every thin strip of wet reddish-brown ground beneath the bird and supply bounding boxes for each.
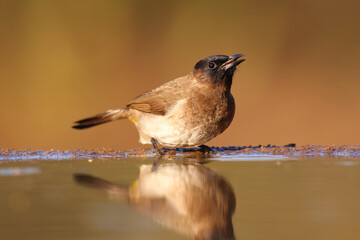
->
[0,144,360,161]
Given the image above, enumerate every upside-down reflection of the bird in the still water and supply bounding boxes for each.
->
[74,164,236,239]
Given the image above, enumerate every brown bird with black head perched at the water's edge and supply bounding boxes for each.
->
[73,54,245,153]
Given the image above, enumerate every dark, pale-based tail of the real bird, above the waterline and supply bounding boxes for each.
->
[72,108,130,129]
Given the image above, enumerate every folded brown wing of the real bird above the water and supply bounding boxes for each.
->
[126,76,190,115]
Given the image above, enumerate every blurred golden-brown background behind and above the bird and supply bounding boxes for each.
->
[0,0,360,150]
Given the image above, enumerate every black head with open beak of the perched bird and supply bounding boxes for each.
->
[193,54,245,88]
